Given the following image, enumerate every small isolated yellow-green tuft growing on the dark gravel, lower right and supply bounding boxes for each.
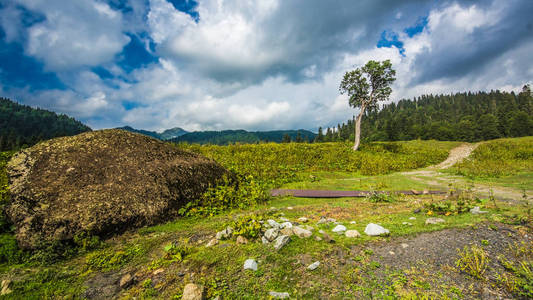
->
[455,245,489,279]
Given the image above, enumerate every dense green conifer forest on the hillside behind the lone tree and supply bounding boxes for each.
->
[316,85,533,142]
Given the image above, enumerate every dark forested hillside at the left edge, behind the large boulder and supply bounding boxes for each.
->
[0,98,91,151]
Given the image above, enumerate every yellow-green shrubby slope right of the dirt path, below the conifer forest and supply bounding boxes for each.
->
[453,137,533,177]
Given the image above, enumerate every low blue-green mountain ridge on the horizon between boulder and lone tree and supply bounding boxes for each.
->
[170,129,316,145]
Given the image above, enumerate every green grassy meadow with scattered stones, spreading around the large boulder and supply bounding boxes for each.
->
[0,137,533,299]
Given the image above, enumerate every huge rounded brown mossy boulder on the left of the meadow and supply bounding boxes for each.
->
[6,130,227,249]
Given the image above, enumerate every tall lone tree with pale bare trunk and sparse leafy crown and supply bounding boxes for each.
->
[339,60,396,151]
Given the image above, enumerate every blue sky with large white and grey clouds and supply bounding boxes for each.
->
[0,0,533,130]
